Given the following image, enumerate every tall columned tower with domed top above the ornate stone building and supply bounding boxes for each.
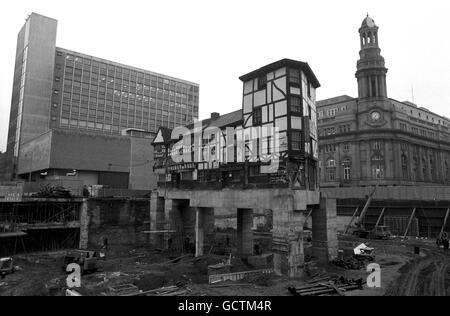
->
[356,15,387,100]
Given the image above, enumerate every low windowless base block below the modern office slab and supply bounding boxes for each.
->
[18,130,157,190]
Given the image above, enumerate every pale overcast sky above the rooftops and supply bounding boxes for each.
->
[0,0,450,151]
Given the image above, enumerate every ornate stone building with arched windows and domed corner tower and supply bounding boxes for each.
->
[317,16,450,187]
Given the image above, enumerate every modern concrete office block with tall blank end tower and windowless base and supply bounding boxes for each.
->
[2,13,199,188]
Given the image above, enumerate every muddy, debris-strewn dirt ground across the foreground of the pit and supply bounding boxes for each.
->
[0,236,450,296]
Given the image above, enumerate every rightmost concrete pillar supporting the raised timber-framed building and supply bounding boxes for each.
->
[312,197,338,262]
